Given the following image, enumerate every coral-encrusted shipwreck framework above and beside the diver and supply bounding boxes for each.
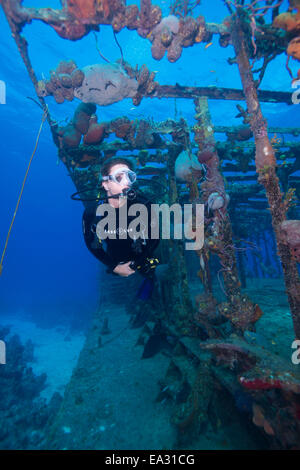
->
[1,0,300,449]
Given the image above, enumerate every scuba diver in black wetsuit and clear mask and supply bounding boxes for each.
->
[82,157,159,282]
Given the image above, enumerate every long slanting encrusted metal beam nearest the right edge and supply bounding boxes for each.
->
[231,13,300,338]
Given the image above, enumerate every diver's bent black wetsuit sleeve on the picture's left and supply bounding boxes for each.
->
[82,209,117,272]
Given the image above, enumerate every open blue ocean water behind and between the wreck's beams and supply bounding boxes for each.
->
[0,0,299,452]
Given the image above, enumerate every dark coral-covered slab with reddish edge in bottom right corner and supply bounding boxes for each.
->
[201,336,300,449]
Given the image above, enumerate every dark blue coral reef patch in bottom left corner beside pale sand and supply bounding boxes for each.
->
[0,328,62,450]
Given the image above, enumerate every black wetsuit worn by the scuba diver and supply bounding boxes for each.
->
[82,194,159,274]
